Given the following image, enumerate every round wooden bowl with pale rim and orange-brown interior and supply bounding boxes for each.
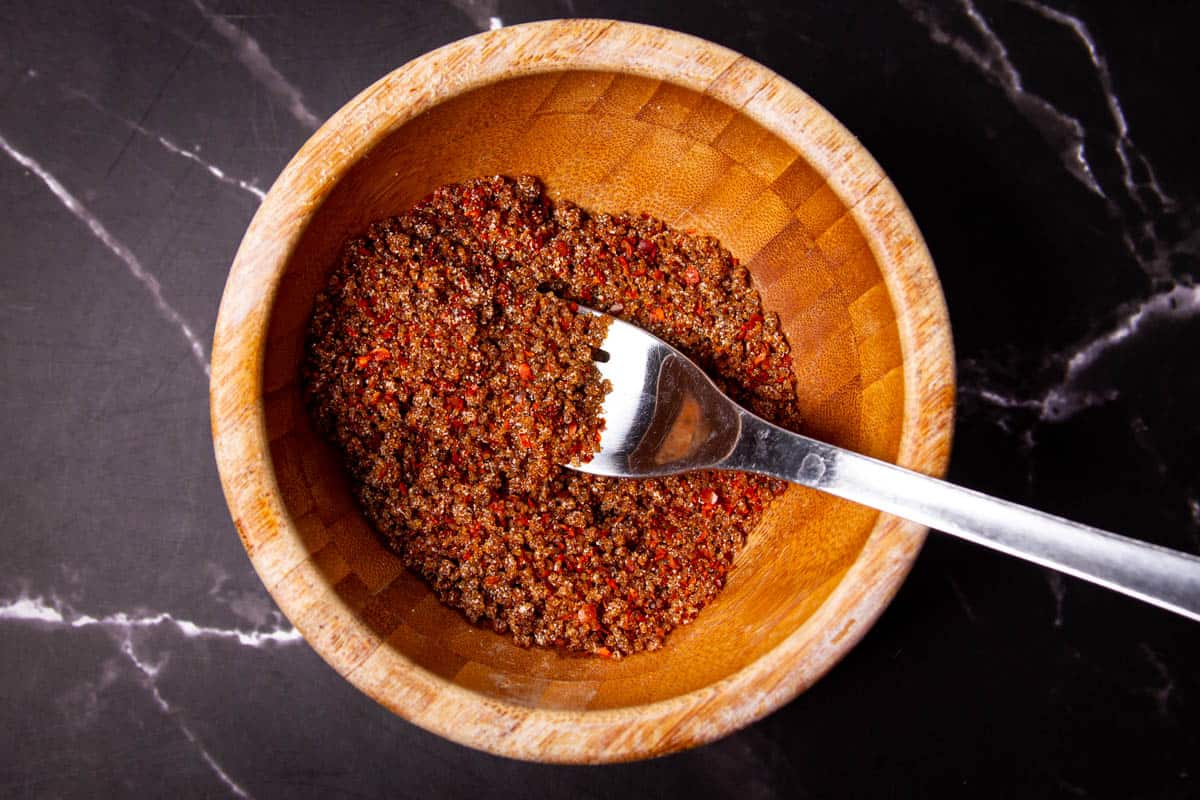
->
[211,20,954,762]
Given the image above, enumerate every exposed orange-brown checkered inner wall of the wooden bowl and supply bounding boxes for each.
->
[264,71,905,709]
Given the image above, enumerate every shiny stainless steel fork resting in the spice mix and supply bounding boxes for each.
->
[571,312,1200,620]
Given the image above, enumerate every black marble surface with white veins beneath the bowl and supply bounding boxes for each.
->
[0,0,1200,799]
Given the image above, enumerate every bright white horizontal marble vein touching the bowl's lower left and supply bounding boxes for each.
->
[0,595,301,648]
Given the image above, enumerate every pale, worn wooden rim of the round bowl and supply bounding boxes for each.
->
[210,19,955,763]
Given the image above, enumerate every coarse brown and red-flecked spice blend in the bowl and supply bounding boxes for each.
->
[304,176,799,657]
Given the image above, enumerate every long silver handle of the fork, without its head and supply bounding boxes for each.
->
[720,410,1200,620]
